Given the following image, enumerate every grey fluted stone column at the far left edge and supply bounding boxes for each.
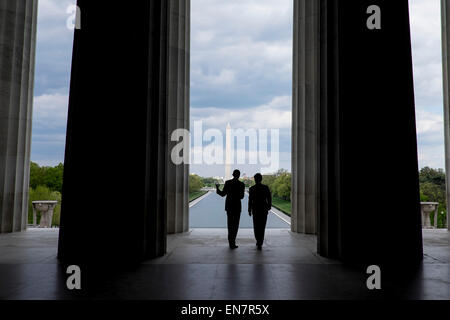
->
[0,0,38,233]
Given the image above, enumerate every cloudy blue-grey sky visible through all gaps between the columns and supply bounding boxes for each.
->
[31,0,444,176]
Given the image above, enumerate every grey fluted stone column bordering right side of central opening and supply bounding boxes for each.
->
[291,0,320,234]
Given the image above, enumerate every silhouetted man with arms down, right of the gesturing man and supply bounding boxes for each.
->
[248,173,272,250]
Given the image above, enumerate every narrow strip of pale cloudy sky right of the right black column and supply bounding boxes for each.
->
[410,0,444,168]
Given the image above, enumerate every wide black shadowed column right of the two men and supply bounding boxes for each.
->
[318,0,423,266]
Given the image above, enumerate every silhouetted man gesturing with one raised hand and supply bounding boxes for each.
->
[216,170,245,249]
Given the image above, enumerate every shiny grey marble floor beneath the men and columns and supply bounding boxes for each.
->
[0,229,450,300]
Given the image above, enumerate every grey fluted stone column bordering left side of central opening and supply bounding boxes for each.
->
[167,0,191,234]
